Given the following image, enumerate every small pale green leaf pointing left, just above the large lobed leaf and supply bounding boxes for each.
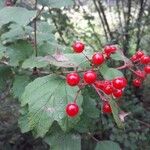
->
[22,57,49,69]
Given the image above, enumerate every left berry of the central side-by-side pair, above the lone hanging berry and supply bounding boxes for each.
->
[66,73,80,86]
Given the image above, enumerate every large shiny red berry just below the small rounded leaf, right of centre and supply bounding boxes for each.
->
[112,77,127,89]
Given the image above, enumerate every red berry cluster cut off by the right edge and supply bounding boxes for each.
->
[130,50,150,87]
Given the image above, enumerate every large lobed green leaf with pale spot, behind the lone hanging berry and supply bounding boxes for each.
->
[21,75,82,137]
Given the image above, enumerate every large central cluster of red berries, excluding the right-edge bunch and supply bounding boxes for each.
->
[66,42,127,117]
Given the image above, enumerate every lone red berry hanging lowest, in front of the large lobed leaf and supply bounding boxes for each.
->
[66,103,79,117]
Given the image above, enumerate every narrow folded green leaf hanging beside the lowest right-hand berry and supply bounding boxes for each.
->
[109,99,124,128]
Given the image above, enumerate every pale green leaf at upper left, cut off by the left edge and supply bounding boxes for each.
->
[0,7,36,27]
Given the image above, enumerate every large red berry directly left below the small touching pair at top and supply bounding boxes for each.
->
[92,53,104,65]
